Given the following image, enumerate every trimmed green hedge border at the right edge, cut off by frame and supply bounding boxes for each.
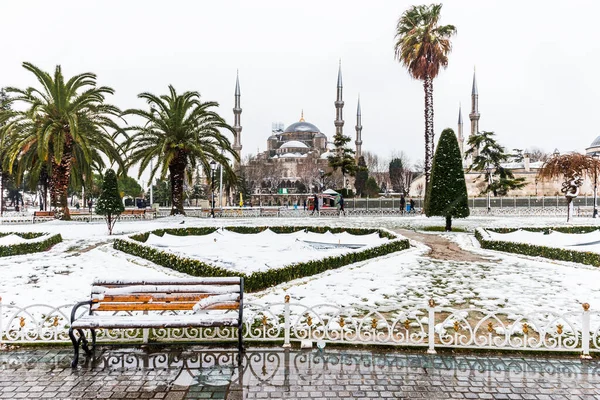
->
[475,226,600,267]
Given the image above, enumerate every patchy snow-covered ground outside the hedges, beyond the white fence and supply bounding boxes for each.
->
[0,216,600,318]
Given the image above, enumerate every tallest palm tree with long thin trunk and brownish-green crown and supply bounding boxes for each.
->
[394,4,456,191]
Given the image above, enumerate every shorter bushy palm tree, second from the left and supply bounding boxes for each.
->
[125,85,239,215]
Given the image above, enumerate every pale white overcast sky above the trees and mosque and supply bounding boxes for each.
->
[0,0,600,181]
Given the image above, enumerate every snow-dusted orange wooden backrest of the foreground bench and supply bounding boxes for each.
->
[91,278,244,312]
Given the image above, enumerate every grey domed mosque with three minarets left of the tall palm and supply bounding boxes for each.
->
[233,63,362,202]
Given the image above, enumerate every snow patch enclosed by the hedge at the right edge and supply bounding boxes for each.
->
[488,230,600,253]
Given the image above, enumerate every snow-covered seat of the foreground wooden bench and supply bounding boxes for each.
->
[72,314,238,329]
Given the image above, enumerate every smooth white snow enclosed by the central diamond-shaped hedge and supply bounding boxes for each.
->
[145,229,388,275]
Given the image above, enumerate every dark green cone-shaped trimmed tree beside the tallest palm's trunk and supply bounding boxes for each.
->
[425,128,469,231]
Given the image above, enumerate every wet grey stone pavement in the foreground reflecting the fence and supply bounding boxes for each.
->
[0,347,600,400]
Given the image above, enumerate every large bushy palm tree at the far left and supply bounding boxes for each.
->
[5,62,123,219]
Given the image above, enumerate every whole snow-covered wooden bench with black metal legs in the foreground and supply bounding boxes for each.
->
[69,278,244,367]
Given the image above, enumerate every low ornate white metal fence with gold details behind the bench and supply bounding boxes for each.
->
[0,296,600,357]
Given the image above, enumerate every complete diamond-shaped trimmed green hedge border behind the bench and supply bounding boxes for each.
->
[113,226,410,292]
